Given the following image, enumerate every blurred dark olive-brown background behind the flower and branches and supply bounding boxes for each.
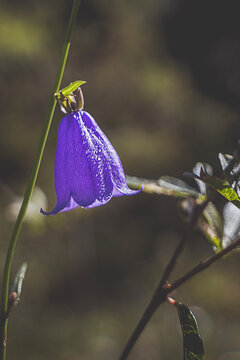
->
[0,0,240,360]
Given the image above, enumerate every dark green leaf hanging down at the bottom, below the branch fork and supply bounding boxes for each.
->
[176,303,205,360]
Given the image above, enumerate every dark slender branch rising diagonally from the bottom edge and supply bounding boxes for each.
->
[119,191,215,360]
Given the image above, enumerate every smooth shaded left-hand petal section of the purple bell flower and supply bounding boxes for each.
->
[41,113,95,215]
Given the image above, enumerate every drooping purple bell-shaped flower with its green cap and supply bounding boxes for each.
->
[41,81,139,215]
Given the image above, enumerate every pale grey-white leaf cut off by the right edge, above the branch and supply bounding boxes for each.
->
[223,203,240,247]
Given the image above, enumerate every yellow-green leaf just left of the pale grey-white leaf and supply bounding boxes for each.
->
[198,202,223,251]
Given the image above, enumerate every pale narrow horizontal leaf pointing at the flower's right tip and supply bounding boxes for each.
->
[127,176,202,198]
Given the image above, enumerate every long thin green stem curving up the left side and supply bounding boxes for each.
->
[0,0,81,360]
